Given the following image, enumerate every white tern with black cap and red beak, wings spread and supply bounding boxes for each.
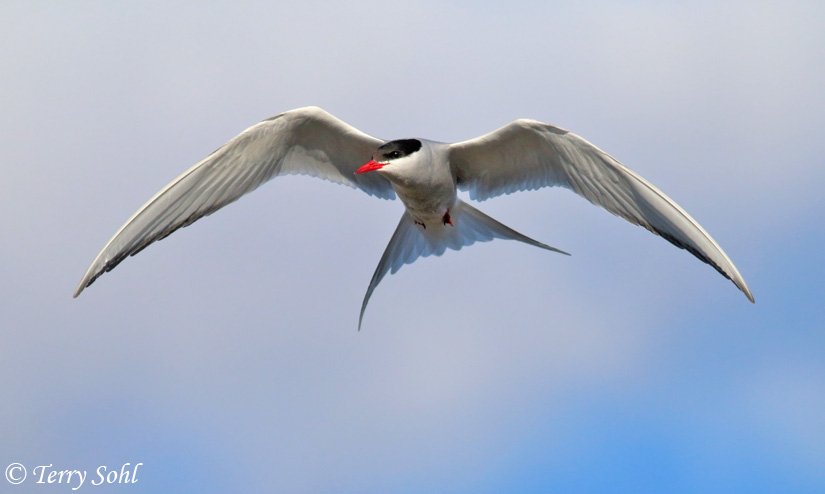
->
[74,107,754,329]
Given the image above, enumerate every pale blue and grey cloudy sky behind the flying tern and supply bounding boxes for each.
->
[0,0,825,493]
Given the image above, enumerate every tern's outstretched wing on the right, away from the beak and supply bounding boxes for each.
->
[449,120,753,302]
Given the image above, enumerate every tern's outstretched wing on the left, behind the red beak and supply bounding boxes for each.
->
[74,107,395,297]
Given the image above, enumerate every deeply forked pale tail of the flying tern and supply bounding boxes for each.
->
[358,199,570,330]
